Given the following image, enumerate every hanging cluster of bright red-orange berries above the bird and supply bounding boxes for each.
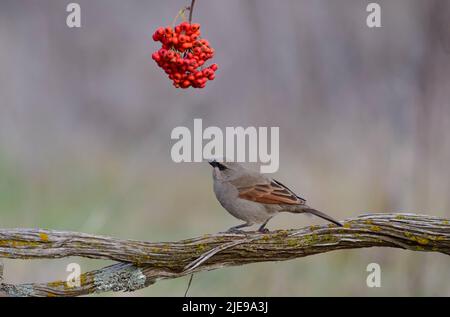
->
[152,22,218,89]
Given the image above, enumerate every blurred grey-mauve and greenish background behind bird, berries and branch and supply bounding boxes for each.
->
[0,0,450,296]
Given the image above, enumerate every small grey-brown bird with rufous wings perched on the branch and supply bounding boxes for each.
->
[208,159,342,233]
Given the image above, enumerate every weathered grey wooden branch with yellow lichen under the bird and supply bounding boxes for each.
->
[0,214,450,296]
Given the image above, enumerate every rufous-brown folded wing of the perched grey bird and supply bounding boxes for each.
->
[237,180,306,205]
